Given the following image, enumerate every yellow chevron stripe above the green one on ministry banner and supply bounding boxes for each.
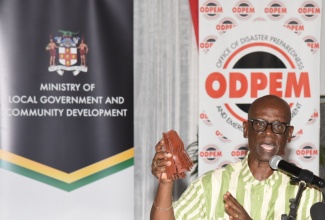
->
[0,148,134,183]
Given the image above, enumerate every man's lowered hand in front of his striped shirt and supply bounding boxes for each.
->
[223,192,252,220]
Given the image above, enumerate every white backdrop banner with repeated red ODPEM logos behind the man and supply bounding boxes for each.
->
[199,0,322,175]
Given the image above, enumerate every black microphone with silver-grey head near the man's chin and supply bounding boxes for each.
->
[269,155,325,188]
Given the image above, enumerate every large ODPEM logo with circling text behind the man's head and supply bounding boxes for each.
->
[205,34,311,130]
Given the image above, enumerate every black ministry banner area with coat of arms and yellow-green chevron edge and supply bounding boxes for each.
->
[0,0,134,191]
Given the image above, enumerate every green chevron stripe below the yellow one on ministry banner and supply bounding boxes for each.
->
[0,158,134,192]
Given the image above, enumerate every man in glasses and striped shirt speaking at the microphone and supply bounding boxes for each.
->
[150,95,322,220]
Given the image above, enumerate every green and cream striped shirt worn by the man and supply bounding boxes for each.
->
[173,156,322,220]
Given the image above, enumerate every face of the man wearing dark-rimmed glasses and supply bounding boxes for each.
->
[243,101,293,162]
